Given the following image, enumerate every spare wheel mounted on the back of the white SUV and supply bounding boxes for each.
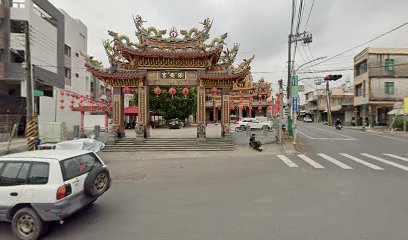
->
[84,167,109,197]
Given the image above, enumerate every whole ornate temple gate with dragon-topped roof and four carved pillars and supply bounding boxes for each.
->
[85,16,254,139]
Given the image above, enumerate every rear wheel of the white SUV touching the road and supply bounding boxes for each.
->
[11,207,48,240]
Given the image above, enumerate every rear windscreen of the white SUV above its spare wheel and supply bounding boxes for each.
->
[61,153,102,181]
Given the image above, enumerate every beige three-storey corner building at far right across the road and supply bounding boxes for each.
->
[354,48,408,126]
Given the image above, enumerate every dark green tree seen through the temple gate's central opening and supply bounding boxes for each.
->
[132,88,197,120]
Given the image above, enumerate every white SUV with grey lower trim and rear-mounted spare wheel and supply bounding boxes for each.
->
[0,150,111,240]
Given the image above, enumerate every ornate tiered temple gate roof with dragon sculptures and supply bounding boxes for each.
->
[84,16,254,85]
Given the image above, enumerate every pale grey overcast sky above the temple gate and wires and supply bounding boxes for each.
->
[50,0,408,96]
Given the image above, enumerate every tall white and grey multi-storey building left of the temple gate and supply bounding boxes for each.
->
[0,0,91,135]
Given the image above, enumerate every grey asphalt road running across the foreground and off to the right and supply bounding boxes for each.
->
[0,124,408,240]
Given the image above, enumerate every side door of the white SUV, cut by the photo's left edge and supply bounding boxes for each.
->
[0,161,30,211]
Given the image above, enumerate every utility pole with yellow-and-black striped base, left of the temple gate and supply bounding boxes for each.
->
[25,21,38,151]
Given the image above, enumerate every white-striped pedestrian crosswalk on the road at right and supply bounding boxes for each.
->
[276,153,408,171]
